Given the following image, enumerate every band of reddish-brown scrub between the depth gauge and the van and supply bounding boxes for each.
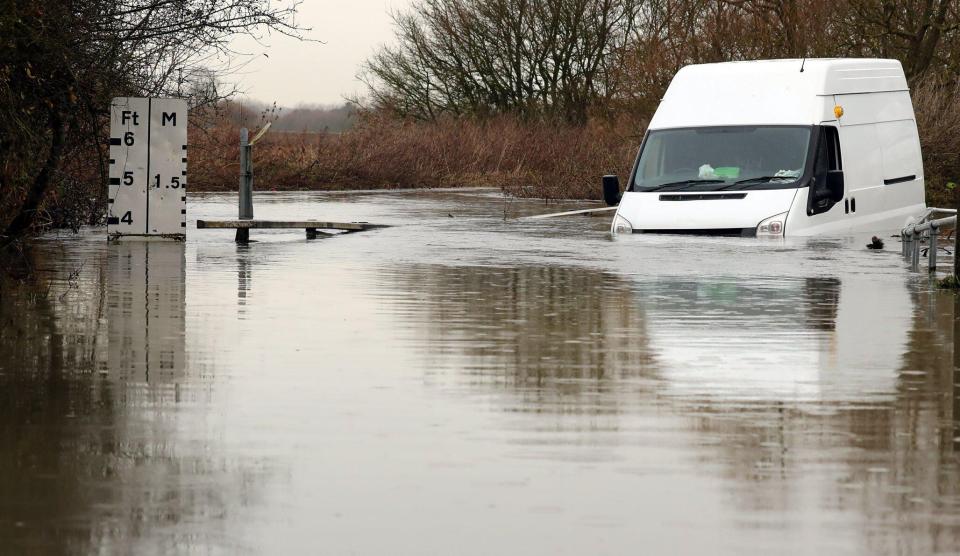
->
[190,111,644,199]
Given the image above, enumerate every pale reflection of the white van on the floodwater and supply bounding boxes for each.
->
[636,275,915,401]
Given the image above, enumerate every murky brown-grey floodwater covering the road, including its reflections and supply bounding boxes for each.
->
[0,191,960,554]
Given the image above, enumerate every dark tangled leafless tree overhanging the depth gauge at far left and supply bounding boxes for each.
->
[0,0,302,243]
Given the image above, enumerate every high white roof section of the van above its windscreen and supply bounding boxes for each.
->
[649,58,908,129]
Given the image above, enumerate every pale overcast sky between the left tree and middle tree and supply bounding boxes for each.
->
[225,0,411,107]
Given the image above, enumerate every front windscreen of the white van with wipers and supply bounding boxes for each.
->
[633,126,812,191]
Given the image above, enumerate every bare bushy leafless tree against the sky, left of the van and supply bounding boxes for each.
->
[363,0,638,123]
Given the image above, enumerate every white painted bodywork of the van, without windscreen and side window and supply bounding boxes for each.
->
[611,59,926,235]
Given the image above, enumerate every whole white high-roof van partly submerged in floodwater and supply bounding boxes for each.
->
[603,59,926,237]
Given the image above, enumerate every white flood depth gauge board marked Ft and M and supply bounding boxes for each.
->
[107,97,188,239]
